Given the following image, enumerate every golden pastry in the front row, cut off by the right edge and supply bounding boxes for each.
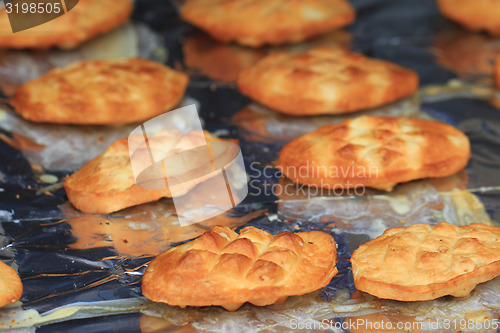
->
[351,222,500,301]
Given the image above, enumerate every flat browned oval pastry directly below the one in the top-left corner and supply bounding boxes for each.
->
[11,59,189,125]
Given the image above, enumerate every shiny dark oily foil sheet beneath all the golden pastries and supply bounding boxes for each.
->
[0,0,500,333]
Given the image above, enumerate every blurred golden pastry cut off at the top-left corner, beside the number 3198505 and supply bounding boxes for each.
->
[0,0,133,49]
